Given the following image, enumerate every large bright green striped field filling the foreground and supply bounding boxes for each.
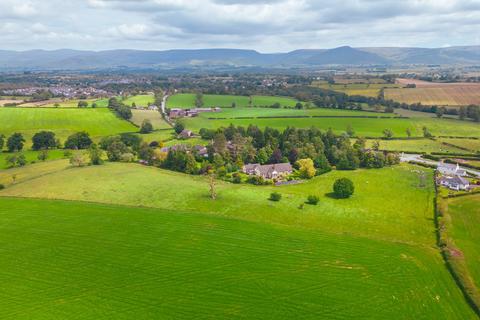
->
[0,198,475,319]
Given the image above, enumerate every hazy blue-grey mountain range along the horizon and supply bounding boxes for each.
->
[0,46,480,70]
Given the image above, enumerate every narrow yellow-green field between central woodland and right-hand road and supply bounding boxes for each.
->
[367,139,465,153]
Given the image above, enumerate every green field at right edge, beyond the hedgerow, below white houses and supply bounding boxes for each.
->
[448,195,480,289]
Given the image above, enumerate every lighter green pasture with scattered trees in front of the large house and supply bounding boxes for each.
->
[0,162,444,243]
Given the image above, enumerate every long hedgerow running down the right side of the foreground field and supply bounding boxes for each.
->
[433,181,480,317]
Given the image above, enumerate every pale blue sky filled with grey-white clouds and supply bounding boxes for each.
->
[0,0,480,52]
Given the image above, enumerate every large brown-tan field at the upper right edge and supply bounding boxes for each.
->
[385,84,480,106]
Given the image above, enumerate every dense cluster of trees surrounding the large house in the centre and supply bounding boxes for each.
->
[163,125,399,178]
